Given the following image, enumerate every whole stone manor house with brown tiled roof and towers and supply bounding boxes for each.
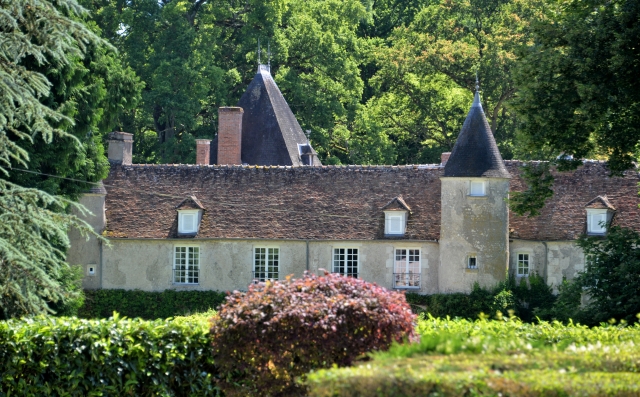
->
[68,65,640,294]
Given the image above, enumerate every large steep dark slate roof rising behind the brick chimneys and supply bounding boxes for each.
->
[210,65,322,165]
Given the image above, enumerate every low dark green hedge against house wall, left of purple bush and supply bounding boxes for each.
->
[78,289,227,320]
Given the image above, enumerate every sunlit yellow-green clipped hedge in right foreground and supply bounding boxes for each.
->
[306,317,640,397]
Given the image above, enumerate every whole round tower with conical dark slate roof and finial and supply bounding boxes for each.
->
[438,82,511,292]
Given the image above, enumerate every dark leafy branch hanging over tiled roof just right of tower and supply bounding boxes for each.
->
[509,162,554,217]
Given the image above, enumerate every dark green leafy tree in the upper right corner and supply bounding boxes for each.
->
[513,0,640,173]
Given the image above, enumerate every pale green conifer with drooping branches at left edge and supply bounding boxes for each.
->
[0,0,101,318]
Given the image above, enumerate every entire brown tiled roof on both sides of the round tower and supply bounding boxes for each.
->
[104,161,640,241]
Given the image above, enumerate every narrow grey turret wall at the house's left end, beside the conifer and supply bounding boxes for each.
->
[67,194,105,289]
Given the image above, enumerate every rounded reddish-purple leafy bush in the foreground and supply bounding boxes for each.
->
[210,273,415,396]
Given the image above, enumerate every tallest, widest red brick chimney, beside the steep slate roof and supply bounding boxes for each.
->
[218,107,244,165]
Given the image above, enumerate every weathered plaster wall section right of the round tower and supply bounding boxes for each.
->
[509,240,584,293]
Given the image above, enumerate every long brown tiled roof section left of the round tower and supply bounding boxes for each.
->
[105,165,442,240]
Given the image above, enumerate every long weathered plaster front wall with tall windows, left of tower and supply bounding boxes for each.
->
[102,239,439,293]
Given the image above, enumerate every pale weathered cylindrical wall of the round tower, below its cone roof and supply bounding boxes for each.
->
[438,177,509,293]
